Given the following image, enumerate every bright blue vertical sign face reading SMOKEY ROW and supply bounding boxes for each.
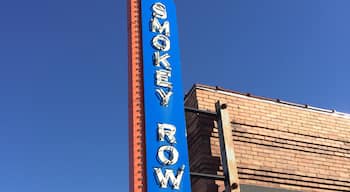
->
[141,0,191,192]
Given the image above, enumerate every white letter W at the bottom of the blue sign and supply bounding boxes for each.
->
[154,165,185,189]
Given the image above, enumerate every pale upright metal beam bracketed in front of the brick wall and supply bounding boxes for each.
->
[215,101,240,192]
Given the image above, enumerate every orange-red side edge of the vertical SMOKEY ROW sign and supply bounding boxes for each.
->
[128,0,146,192]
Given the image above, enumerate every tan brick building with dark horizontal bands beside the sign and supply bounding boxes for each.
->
[185,85,350,192]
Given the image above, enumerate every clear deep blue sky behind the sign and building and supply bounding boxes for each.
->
[0,0,350,192]
